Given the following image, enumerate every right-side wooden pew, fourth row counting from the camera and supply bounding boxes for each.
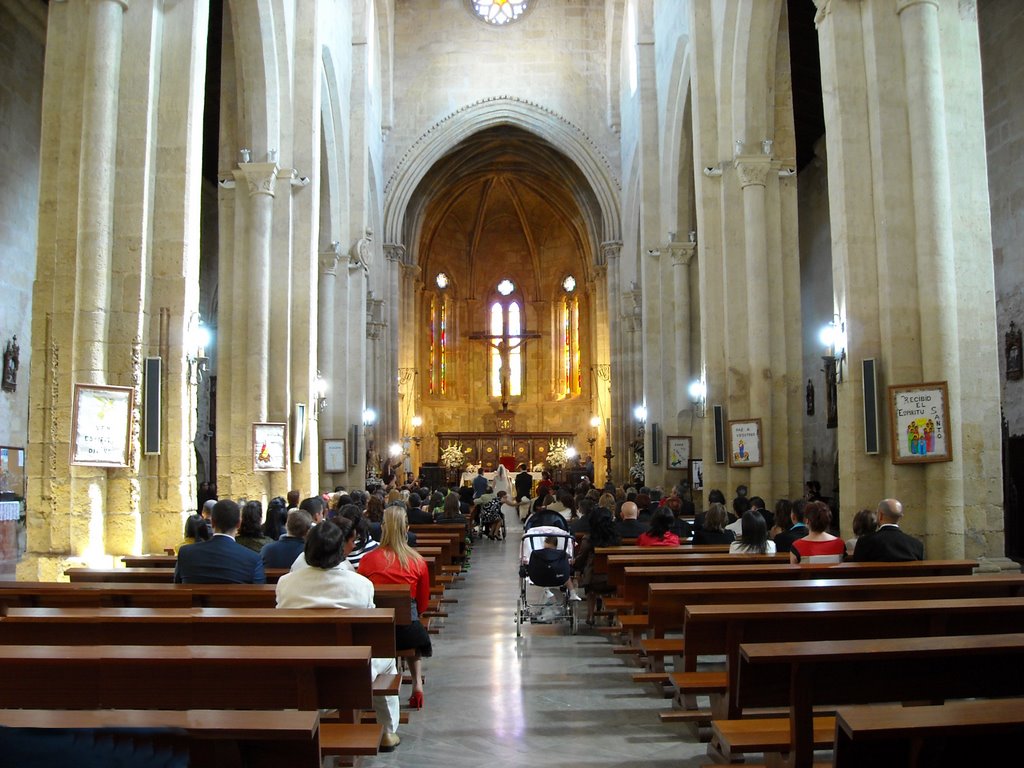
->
[648,573,1024,637]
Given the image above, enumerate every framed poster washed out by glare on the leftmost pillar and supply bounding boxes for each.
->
[71,384,135,467]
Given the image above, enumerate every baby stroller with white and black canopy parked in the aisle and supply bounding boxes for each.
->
[515,525,579,637]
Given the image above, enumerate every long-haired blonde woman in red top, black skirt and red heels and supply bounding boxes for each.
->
[359,505,433,709]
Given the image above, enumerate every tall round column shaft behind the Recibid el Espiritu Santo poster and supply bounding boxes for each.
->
[896,0,964,557]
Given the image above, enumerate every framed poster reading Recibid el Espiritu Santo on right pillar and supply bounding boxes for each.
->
[889,381,953,464]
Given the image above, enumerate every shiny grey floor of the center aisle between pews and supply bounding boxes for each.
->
[358,520,710,768]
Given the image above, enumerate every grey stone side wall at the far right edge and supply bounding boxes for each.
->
[978,0,1024,434]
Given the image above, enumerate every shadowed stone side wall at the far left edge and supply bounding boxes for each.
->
[0,5,44,456]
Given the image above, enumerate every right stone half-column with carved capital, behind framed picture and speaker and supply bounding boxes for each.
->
[732,156,782,498]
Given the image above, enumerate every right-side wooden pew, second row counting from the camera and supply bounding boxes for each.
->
[712,634,1024,768]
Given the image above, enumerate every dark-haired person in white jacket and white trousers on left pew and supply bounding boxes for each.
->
[276,520,399,752]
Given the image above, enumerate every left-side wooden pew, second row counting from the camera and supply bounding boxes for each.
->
[0,645,382,754]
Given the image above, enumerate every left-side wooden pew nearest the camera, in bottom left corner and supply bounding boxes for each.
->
[0,710,323,768]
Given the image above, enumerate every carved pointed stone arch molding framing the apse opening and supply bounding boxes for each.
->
[384,95,622,240]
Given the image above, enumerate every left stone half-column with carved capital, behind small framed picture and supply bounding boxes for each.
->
[236,163,279,499]
